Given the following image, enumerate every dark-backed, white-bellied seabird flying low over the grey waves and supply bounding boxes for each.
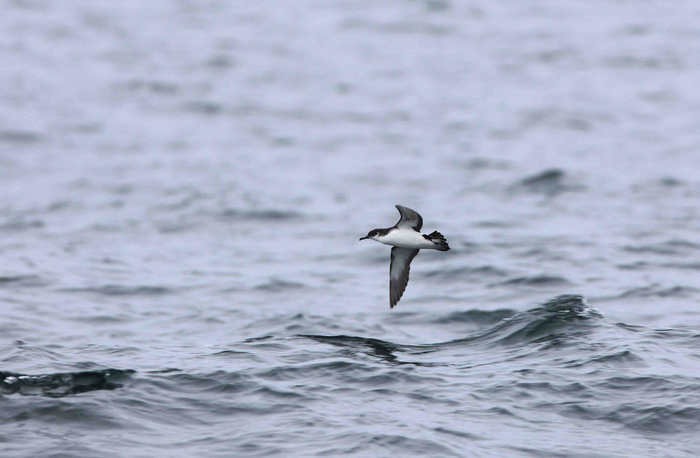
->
[360,205,450,309]
